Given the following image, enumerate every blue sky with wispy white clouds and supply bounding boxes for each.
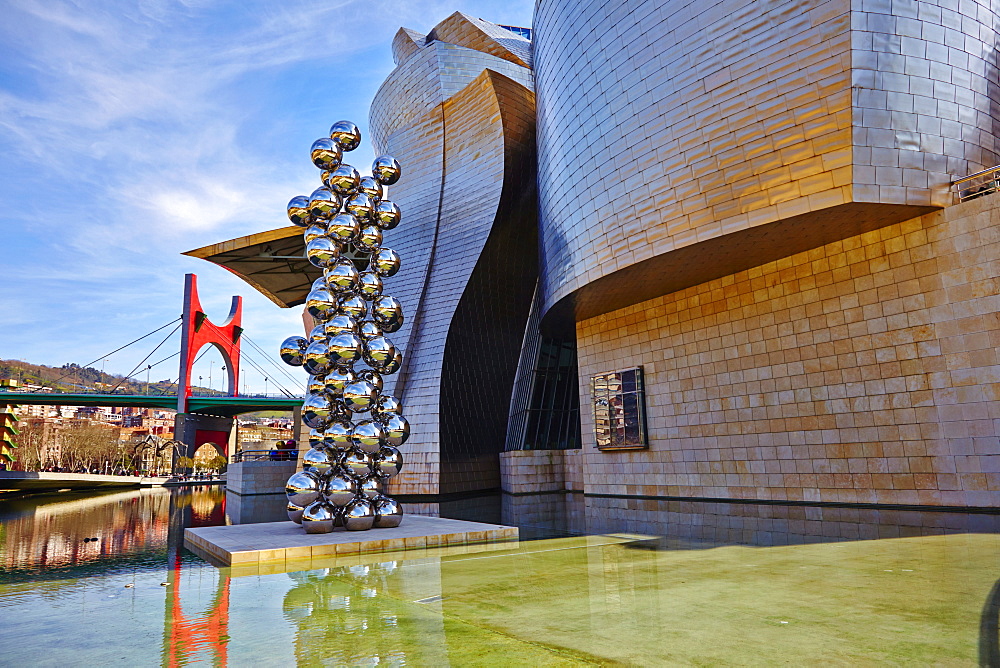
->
[0,0,534,393]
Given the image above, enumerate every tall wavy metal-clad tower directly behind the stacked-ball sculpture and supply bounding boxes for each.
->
[370,16,537,494]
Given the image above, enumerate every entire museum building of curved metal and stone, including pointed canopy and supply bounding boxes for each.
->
[189,0,1000,507]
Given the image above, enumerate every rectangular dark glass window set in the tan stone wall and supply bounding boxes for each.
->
[590,367,649,450]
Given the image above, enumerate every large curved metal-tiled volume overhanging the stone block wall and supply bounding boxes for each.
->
[533,0,1000,320]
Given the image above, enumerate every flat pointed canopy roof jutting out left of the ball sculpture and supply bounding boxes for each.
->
[184,225,321,308]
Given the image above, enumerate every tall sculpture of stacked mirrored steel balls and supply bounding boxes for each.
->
[281,121,410,533]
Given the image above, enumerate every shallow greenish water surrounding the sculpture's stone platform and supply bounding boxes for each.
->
[0,488,1000,666]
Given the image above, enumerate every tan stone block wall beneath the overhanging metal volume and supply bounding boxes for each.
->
[576,190,1000,507]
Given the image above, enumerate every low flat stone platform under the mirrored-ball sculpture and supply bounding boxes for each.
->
[184,515,518,566]
